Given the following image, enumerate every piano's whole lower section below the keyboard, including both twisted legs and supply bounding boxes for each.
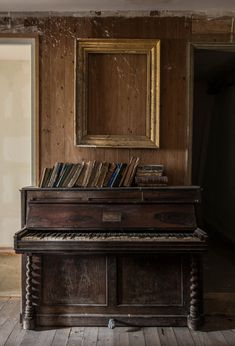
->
[22,253,202,329]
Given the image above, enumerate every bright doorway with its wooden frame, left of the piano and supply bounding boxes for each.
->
[0,37,38,248]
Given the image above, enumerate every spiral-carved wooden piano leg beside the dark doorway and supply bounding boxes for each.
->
[188,255,202,330]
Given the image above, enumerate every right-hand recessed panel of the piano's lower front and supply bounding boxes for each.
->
[118,255,183,306]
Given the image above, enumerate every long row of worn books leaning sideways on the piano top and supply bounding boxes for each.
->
[39,157,139,188]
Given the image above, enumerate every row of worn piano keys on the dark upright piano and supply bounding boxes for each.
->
[21,231,200,241]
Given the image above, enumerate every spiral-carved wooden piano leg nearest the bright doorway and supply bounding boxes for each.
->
[23,255,35,329]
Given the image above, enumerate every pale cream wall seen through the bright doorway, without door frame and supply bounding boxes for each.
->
[0,56,32,247]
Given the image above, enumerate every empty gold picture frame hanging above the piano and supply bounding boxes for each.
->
[75,39,160,149]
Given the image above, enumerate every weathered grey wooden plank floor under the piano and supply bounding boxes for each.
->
[0,298,235,346]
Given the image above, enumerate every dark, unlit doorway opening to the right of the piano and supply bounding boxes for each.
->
[192,46,235,292]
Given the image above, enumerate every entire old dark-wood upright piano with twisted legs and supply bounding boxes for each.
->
[14,186,206,329]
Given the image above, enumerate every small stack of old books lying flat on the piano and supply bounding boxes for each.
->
[135,165,168,187]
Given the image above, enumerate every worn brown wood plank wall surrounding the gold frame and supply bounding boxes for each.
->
[0,15,234,185]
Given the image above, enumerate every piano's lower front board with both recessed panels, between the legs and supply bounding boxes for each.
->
[36,254,190,320]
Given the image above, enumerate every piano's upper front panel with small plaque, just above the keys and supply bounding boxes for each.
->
[26,201,196,231]
